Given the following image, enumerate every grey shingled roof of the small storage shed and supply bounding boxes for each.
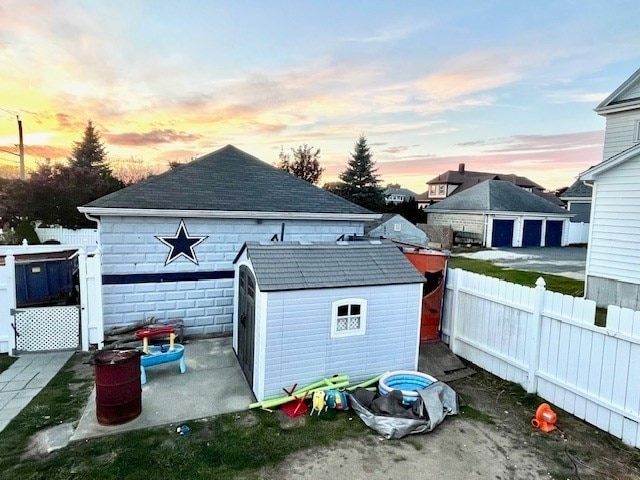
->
[234,241,424,292]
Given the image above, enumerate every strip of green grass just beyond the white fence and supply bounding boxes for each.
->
[449,257,584,297]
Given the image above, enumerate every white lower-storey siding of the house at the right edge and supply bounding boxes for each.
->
[586,157,640,284]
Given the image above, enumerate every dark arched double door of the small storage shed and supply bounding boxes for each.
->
[238,265,256,387]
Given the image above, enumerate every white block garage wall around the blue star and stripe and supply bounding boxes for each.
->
[100,217,363,335]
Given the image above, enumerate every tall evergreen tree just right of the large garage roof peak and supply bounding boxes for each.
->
[340,135,384,211]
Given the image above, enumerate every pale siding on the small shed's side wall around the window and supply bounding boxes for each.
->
[264,284,422,398]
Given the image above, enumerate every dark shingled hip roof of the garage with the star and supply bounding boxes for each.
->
[80,145,372,214]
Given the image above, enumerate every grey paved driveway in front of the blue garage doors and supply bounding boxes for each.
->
[460,247,587,280]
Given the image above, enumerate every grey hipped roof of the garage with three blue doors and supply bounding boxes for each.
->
[426,180,571,216]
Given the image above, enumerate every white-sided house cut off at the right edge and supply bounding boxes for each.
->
[580,70,640,310]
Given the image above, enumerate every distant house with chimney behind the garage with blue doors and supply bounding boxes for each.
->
[416,163,564,208]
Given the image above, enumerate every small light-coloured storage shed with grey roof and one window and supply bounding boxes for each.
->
[233,240,425,401]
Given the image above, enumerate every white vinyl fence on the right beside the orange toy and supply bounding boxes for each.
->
[442,269,640,447]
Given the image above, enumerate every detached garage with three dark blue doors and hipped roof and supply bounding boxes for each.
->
[425,180,571,247]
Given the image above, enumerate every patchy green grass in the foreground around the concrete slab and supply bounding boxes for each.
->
[0,355,375,480]
